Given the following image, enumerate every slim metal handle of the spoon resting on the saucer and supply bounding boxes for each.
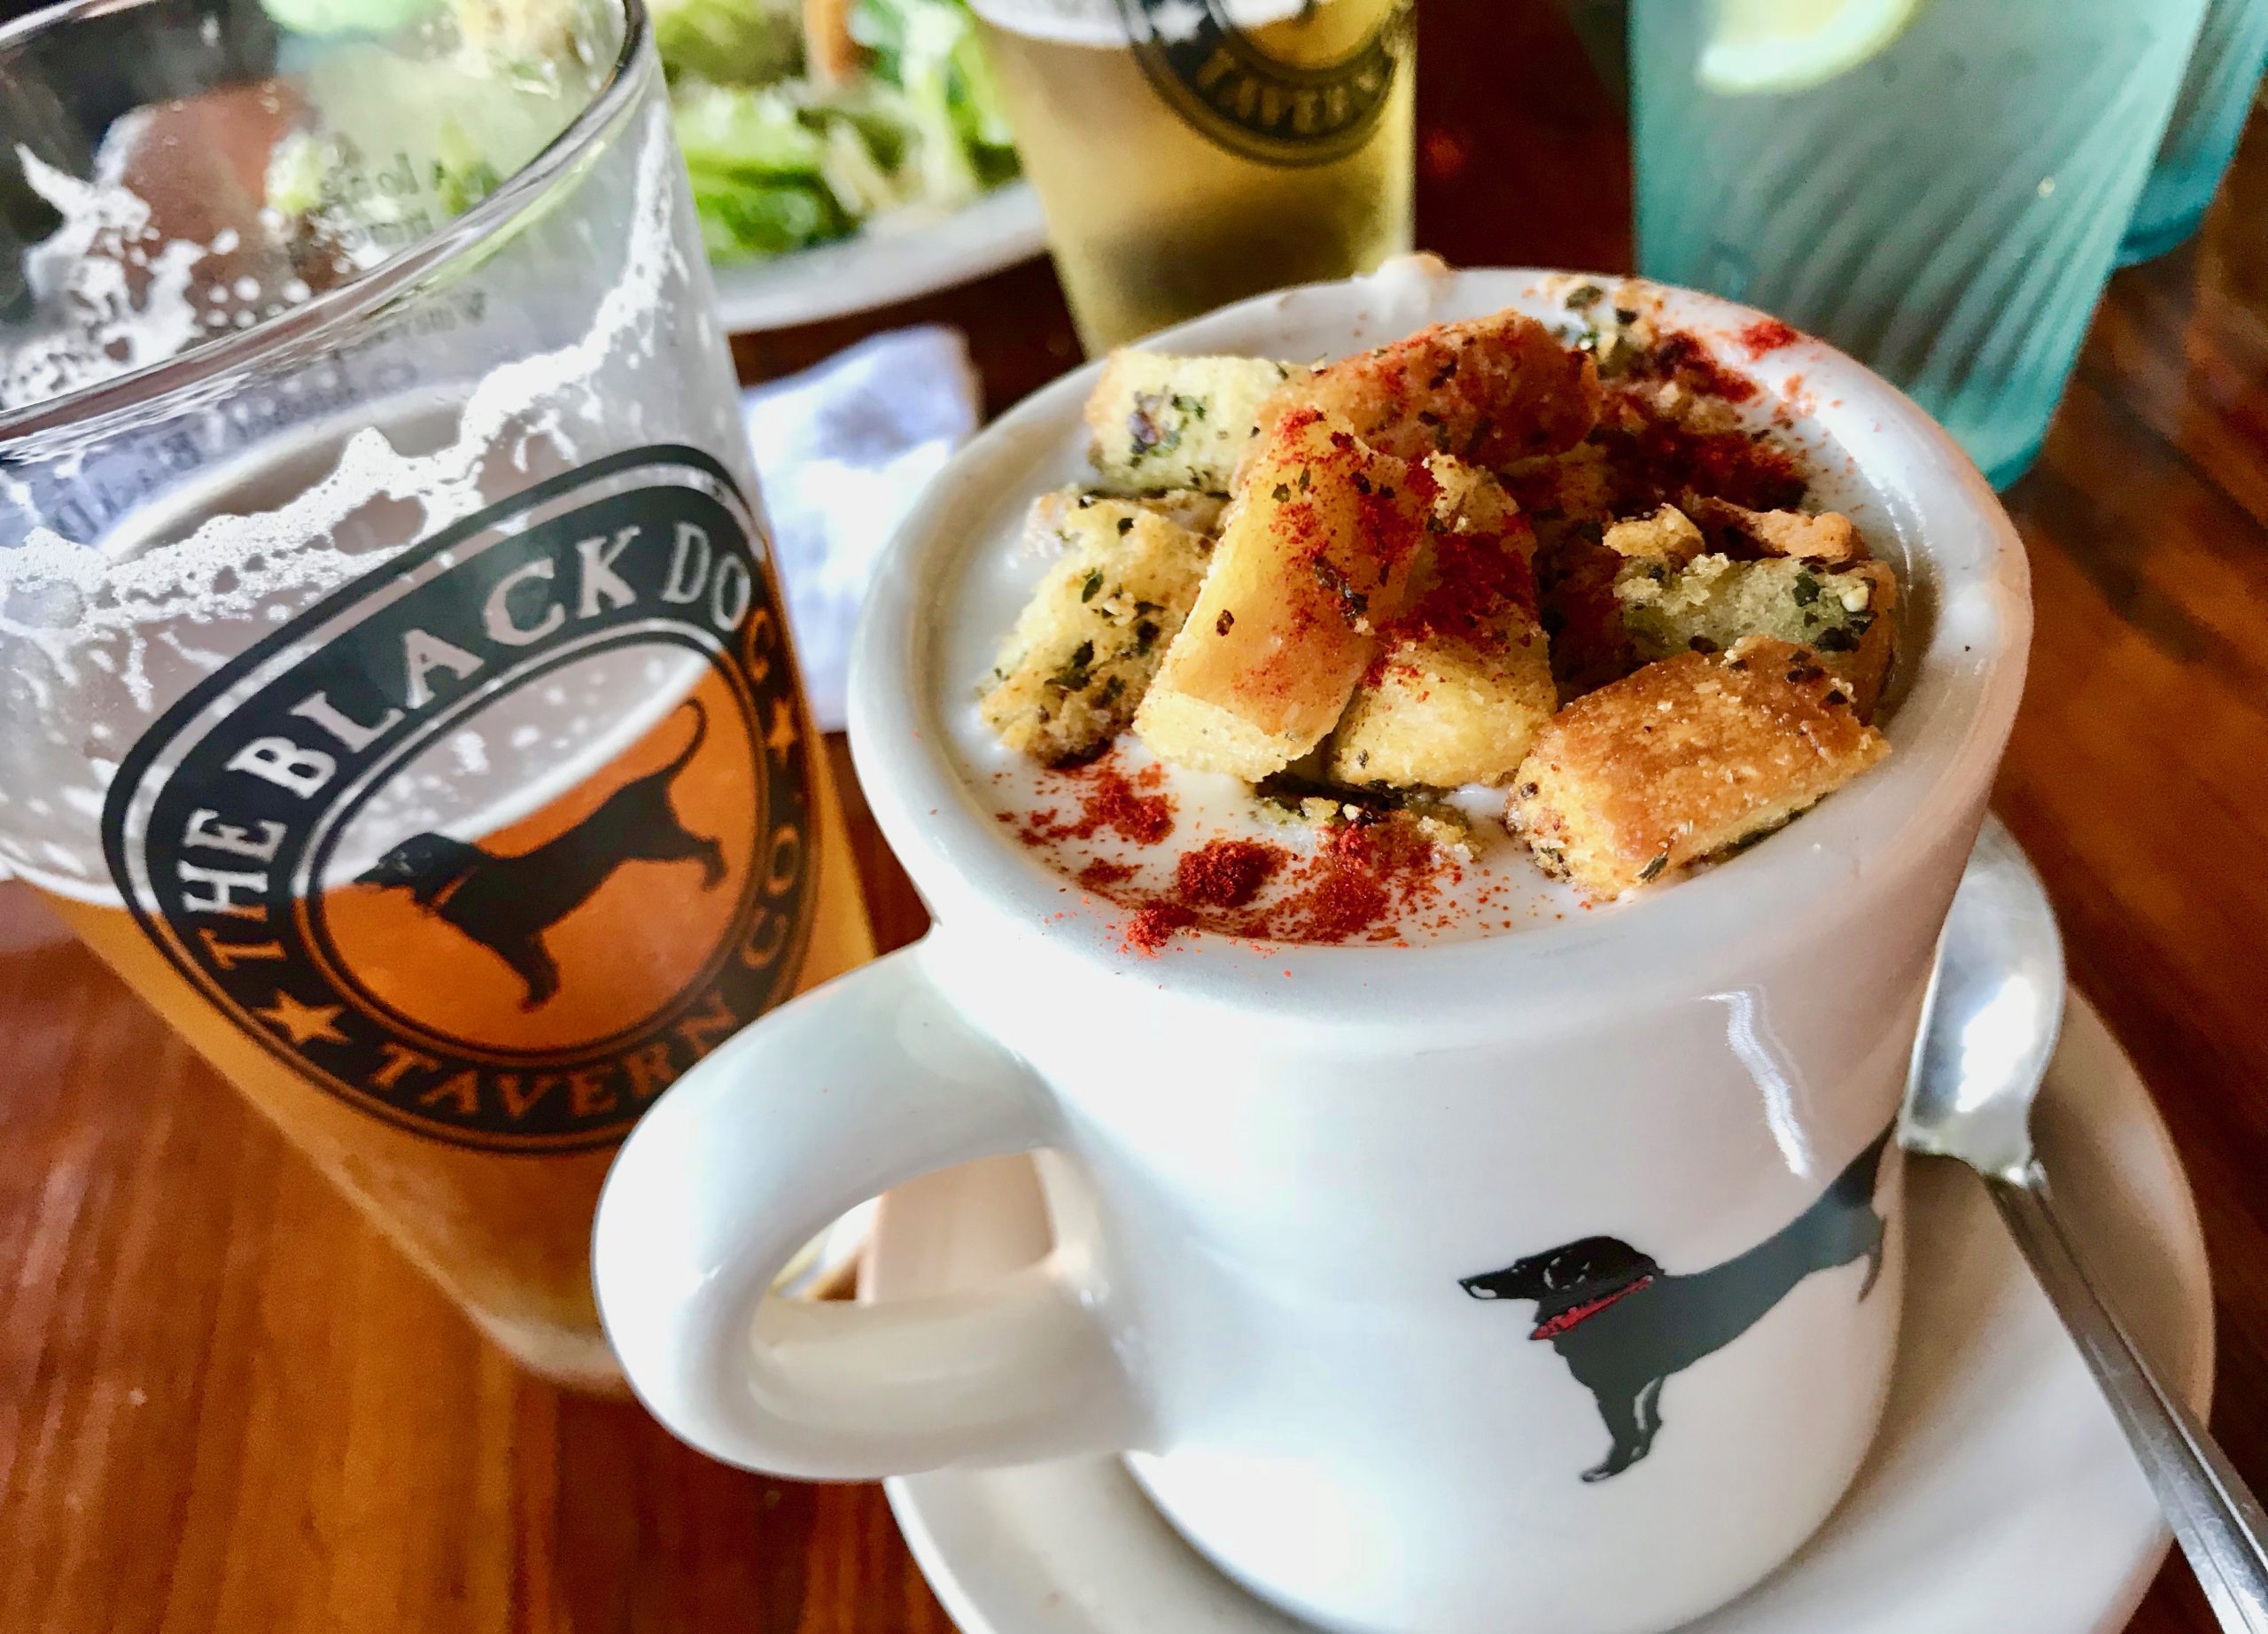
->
[1984,1166,2268,1634]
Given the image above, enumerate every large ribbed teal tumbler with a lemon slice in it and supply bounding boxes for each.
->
[1631,0,2204,488]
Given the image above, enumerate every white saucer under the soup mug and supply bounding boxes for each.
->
[864,994,2214,1634]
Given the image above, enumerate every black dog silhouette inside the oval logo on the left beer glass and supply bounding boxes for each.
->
[353,699,726,1010]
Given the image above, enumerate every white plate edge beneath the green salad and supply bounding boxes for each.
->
[714,182,1048,333]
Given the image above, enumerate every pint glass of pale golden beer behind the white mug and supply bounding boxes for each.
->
[975,0,1415,352]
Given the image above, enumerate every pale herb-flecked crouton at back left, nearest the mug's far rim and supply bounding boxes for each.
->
[1086,352,1307,494]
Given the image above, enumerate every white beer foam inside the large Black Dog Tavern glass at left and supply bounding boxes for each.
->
[0,97,689,901]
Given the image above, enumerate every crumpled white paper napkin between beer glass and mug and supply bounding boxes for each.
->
[742,327,980,731]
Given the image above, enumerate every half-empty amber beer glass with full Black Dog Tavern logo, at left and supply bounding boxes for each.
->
[0,0,871,1387]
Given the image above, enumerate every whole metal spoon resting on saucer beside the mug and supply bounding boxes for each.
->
[1899,820,2268,1634]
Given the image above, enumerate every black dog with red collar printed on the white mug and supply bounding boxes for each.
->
[1458,1130,1889,1482]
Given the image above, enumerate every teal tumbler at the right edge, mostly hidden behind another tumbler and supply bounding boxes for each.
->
[2118,0,2268,266]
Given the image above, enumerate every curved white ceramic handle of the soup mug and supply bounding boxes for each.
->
[592,933,1141,1480]
